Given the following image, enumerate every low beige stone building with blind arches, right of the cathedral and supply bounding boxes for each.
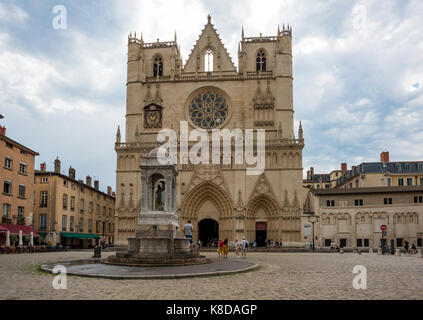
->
[302,186,423,250]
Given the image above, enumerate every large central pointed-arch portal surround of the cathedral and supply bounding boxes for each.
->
[179,182,234,241]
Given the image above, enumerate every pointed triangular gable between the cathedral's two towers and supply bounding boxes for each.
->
[182,15,237,73]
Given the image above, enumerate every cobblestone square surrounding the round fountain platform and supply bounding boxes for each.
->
[0,251,423,300]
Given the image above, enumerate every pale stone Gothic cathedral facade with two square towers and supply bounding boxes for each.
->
[115,16,304,246]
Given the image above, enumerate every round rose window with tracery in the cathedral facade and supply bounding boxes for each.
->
[189,89,228,129]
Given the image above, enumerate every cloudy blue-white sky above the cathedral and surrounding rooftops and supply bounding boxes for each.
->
[0,0,423,190]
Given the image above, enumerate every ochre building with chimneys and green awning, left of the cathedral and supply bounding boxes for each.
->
[34,159,115,248]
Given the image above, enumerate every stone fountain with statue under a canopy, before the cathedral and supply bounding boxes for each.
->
[103,147,210,266]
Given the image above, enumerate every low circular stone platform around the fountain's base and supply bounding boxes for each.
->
[41,259,259,279]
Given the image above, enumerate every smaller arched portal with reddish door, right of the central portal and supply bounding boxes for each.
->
[246,195,281,246]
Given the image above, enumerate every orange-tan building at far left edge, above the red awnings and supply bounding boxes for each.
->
[0,126,38,226]
